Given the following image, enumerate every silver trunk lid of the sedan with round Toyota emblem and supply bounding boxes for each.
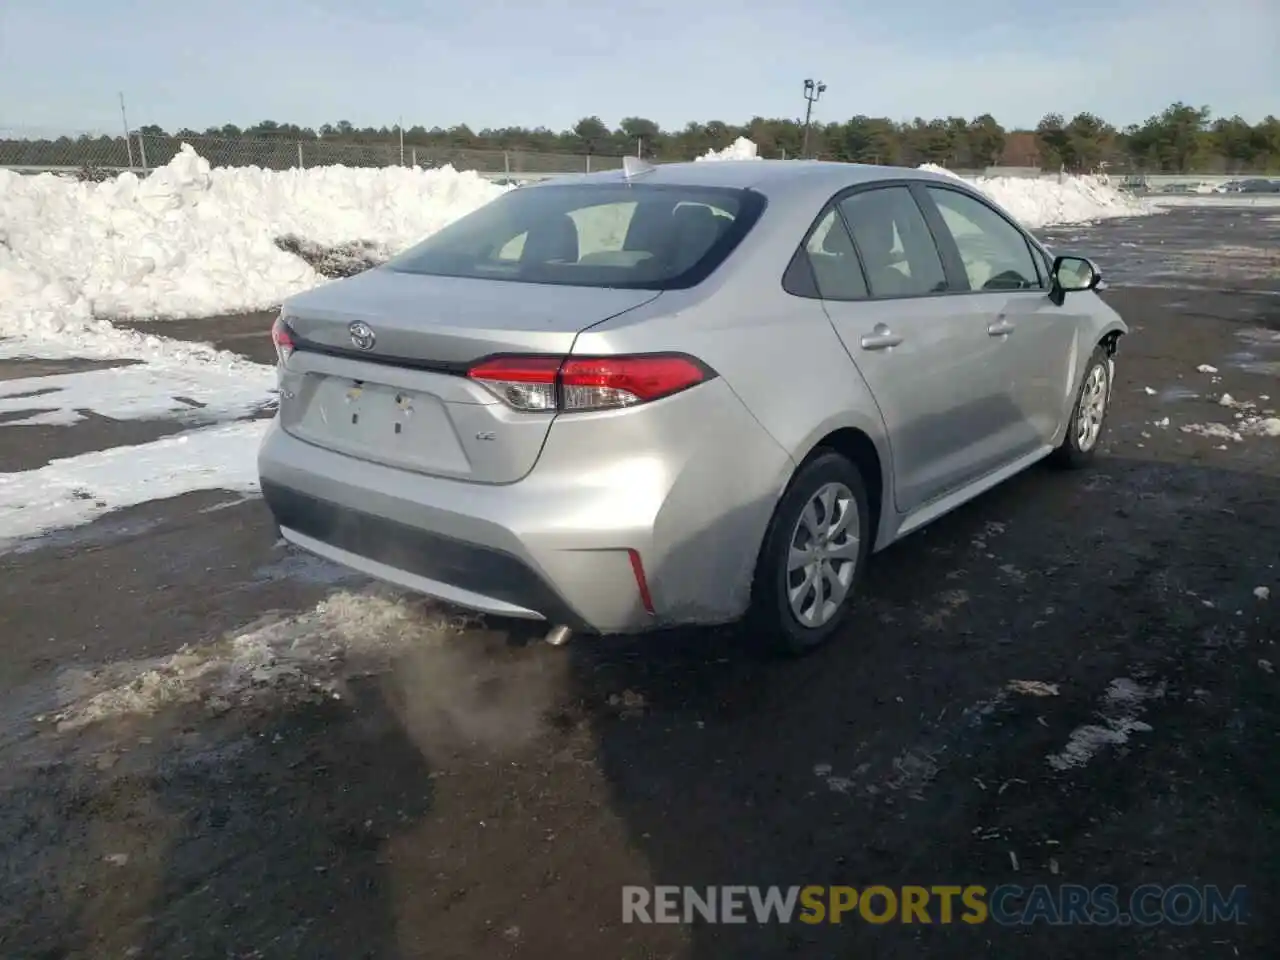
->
[280,269,659,484]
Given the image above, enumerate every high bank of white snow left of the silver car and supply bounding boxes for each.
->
[0,145,507,350]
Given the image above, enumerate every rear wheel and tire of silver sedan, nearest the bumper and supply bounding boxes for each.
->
[751,449,874,657]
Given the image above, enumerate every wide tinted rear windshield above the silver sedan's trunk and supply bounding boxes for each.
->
[387,183,764,289]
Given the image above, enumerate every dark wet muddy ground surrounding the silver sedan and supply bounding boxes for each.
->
[0,200,1280,960]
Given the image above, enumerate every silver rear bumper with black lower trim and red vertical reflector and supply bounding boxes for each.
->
[259,380,792,634]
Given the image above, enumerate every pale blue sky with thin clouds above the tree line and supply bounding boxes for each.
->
[0,0,1280,131]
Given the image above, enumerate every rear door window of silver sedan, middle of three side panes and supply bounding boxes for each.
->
[840,187,947,297]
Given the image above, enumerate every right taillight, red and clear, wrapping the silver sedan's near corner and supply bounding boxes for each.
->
[467,353,716,412]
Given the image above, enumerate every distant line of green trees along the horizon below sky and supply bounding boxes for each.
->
[0,102,1280,174]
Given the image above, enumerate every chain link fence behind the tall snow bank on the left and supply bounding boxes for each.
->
[0,129,622,177]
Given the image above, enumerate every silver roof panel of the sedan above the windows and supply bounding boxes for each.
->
[530,160,959,196]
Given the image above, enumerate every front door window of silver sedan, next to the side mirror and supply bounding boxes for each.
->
[927,187,1042,291]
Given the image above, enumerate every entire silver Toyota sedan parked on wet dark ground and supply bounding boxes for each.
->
[259,160,1128,653]
